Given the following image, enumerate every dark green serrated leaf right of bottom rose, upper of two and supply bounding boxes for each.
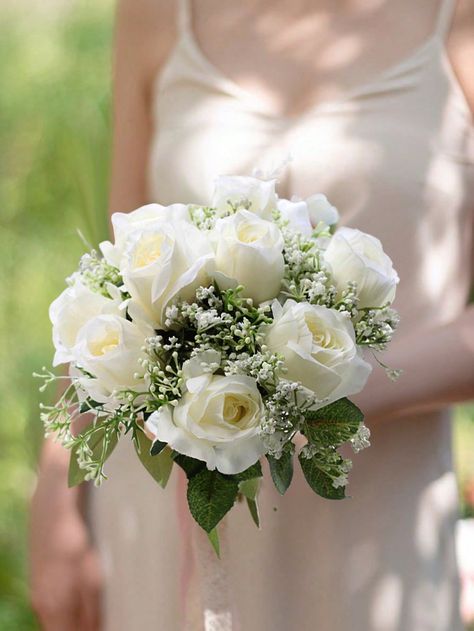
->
[303,399,364,446]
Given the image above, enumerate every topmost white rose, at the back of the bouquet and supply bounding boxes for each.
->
[212,175,277,219]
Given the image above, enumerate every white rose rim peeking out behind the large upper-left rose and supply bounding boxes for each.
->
[99,204,190,267]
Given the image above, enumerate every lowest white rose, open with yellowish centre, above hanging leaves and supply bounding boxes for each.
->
[146,374,264,475]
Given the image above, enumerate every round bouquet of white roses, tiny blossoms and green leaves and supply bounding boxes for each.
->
[36,176,398,550]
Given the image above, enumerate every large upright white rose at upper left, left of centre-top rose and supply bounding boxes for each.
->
[120,215,214,328]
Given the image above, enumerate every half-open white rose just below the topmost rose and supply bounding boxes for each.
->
[212,210,284,303]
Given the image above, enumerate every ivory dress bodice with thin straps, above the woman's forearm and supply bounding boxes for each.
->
[149,0,474,334]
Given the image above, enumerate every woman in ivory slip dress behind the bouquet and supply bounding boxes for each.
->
[32,0,474,631]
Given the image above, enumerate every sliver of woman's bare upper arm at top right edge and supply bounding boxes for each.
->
[448,0,474,114]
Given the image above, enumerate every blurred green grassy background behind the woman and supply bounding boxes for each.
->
[0,0,474,631]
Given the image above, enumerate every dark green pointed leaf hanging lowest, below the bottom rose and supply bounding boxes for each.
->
[188,469,239,532]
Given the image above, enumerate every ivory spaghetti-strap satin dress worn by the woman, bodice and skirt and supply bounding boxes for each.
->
[91,0,474,631]
